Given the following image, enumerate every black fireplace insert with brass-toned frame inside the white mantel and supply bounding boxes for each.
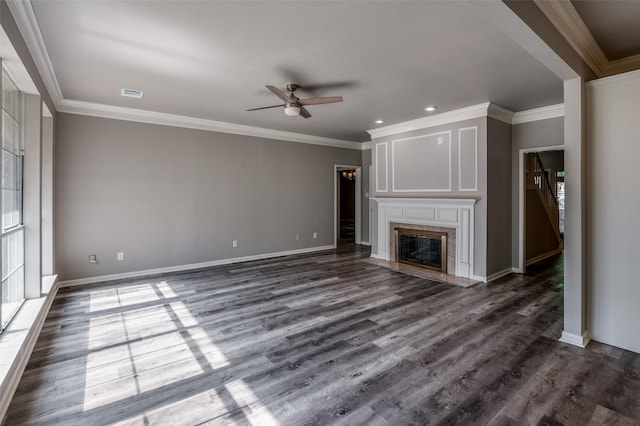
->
[394,228,447,274]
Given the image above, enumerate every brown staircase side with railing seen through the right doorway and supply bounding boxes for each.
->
[525,153,563,265]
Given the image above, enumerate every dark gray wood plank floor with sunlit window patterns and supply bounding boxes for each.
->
[4,246,640,425]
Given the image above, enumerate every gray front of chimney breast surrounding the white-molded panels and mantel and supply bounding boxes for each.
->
[372,117,487,277]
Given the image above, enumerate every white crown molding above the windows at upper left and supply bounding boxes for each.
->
[7,0,64,104]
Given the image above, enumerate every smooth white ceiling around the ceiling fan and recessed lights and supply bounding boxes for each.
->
[31,0,563,141]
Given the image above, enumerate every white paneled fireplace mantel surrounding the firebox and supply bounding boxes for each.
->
[371,198,477,278]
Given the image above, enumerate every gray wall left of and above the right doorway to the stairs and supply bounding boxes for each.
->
[511,117,564,266]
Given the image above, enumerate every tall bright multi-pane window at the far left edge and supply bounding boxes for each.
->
[0,67,24,329]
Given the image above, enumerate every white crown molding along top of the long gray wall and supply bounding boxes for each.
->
[58,99,362,150]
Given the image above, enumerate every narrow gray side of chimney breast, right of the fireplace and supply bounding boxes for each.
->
[486,118,512,276]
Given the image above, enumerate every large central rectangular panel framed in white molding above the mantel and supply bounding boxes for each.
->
[391,131,452,192]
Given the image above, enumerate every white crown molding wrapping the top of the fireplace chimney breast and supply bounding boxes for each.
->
[367,102,513,139]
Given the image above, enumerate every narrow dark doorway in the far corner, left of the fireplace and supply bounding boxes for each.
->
[334,165,362,247]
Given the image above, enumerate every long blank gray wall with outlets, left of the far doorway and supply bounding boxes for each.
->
[55,113,362,280]
